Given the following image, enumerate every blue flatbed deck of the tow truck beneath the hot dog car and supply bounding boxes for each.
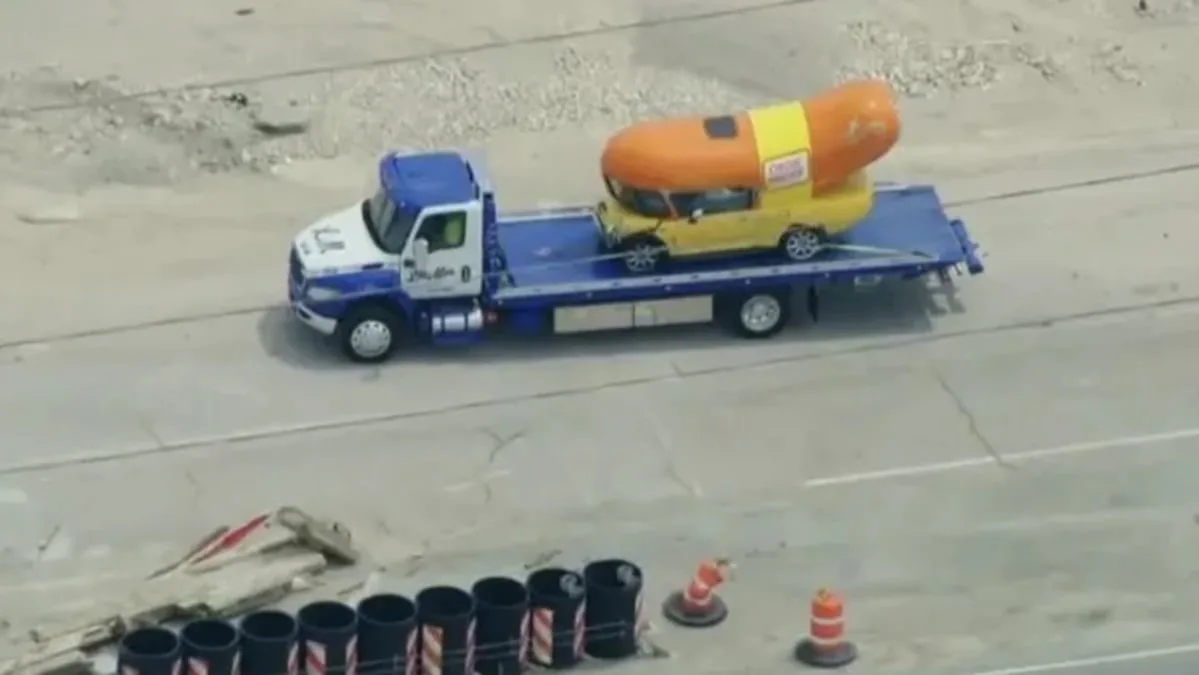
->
[493,185,982,307]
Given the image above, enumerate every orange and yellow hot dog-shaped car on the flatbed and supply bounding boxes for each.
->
[600,80,899,272]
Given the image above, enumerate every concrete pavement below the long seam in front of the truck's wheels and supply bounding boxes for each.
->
[4,282,1199,673]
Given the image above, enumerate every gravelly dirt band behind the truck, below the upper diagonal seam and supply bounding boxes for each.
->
[0,0,1199,186]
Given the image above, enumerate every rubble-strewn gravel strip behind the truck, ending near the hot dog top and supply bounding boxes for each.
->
[0,39,754,183]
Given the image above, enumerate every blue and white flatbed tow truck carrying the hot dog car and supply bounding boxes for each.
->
[288,152,983,362]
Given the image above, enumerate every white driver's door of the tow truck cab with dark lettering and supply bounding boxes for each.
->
[400,201,483,300]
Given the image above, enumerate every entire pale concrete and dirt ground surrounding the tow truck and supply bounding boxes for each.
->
[0,0,1199,675]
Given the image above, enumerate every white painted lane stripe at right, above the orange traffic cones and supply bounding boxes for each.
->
[803,427,1199,488]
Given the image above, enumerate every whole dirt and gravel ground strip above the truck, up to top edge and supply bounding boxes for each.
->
[0,0,1197,197]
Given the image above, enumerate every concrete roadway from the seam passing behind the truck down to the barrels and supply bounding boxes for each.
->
[0,157,1199,673]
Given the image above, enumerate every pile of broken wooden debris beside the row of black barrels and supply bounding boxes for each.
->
[0,506,359,675]
